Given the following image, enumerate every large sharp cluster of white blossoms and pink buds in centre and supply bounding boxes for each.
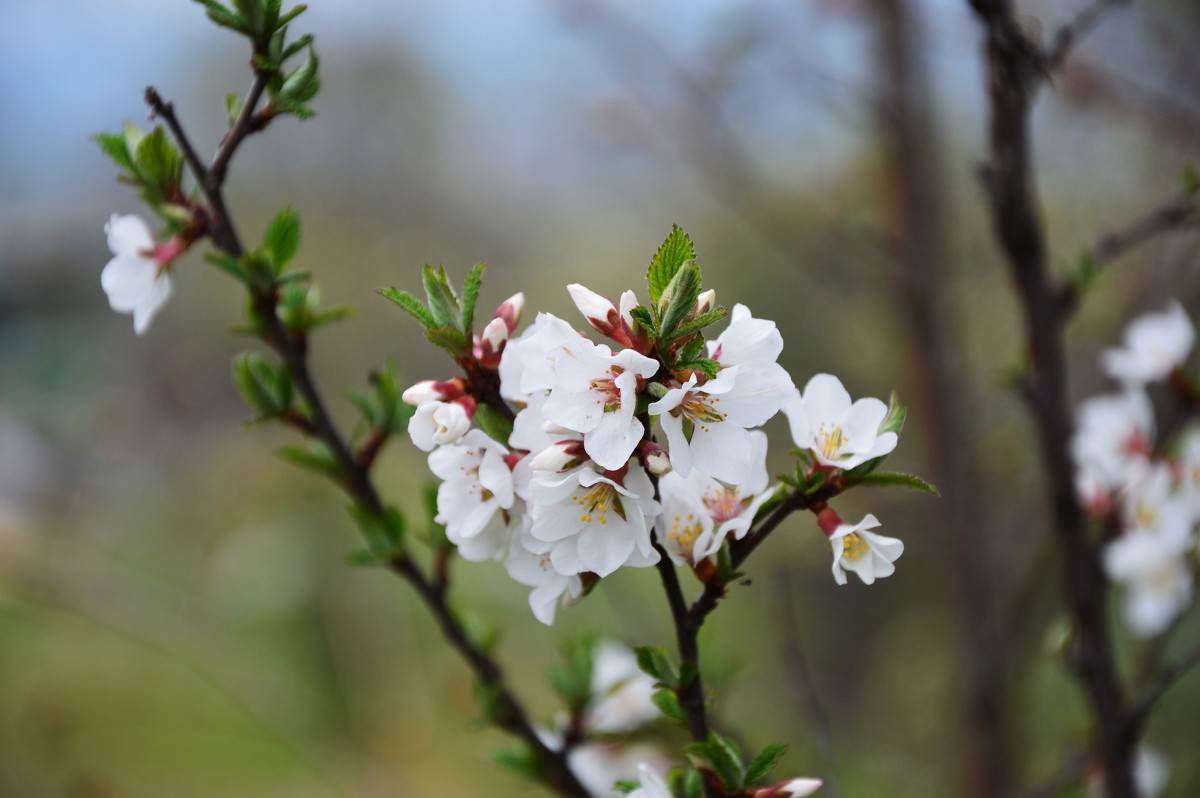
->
[403,239,904,624]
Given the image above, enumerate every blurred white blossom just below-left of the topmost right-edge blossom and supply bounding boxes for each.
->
[1070,390,1154,494]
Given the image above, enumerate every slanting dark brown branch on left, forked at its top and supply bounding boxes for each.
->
[146,84,589,798]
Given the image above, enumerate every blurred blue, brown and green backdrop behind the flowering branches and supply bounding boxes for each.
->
[0,0,1200,798]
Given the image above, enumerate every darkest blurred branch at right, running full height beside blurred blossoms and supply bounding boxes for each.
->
[971,0,1136,798]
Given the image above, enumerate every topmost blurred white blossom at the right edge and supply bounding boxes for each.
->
[1100,300,1195,385]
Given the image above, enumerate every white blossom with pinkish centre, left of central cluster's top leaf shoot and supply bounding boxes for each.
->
[541,338,659,470]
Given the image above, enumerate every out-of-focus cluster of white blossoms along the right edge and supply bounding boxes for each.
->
[1072,302,1200,637]
